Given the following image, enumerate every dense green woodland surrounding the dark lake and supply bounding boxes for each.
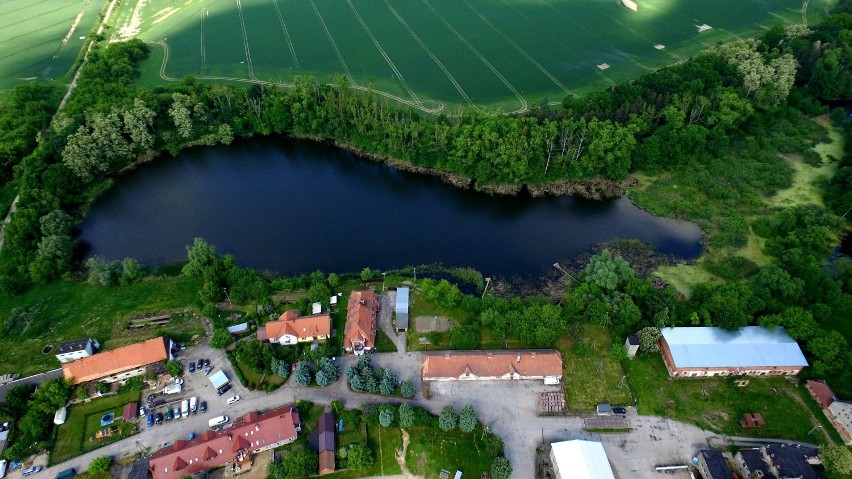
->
[0,0,852,384]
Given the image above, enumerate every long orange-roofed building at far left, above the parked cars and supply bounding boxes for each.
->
[62,336,174,384]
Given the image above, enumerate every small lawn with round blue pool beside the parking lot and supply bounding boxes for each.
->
[50,391,139,464]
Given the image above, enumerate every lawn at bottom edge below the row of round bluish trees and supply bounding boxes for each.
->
[405,427,492,478]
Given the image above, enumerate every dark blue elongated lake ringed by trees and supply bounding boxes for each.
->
[82,138,702,276]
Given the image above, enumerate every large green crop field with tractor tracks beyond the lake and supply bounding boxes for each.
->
[110,0,827,111]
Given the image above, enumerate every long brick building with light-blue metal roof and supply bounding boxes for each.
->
[660,326,808,377]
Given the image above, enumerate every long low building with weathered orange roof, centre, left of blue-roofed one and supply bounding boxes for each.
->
[421,349,562,384]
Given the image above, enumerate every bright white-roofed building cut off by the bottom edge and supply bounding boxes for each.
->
[550,440,615,479]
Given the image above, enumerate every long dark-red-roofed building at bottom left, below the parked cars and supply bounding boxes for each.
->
[148,405,301,479]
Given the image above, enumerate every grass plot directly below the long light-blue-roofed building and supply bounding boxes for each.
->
[628,354,839,444]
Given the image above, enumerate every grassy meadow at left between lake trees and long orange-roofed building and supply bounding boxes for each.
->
[0,277,202,376]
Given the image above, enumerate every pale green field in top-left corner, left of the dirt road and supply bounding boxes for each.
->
[0,0,104,89]
